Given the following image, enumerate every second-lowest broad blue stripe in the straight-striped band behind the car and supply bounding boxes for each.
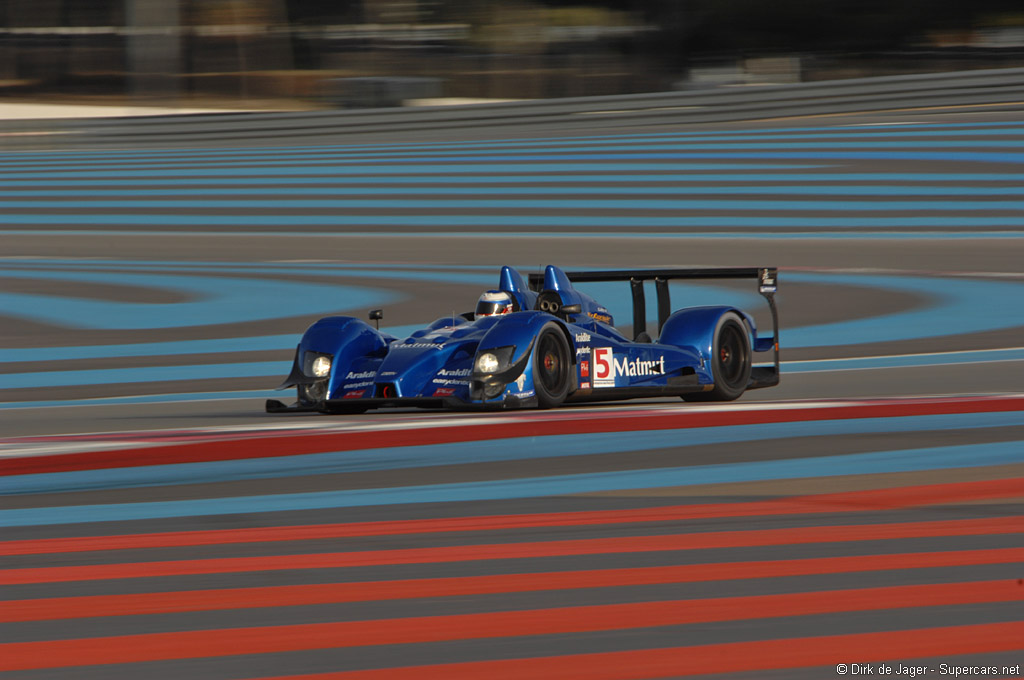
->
[4,197,1024,210]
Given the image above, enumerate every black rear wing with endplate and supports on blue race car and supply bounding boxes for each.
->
[529,267,779,387]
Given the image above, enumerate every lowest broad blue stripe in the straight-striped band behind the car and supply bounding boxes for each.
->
[8,213,1021,228]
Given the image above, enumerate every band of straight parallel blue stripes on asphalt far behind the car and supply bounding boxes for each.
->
[6,120,1024,238]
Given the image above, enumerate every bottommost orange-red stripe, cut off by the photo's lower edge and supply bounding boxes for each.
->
[239,622,1024,680]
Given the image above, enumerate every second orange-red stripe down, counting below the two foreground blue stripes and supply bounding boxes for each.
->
[0,516,1024,585]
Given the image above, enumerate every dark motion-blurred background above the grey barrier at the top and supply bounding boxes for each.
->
[0,0,1024,109]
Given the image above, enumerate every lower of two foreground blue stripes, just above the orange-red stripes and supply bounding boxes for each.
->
[0,441,1024,526]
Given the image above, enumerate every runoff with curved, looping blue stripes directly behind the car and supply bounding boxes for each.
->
[6,258,1024,410]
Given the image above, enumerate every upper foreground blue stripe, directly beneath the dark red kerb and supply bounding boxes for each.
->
[4,413,1024,494]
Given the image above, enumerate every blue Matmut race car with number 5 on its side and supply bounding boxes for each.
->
[266,266,779,413]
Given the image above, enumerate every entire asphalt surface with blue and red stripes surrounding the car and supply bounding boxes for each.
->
[0,107,1024,680]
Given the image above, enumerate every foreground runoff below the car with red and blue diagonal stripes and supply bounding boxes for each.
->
[0,396,1024,680]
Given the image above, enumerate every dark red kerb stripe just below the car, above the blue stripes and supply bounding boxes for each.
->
[8,396,1024,475]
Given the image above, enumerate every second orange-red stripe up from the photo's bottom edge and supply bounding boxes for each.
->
[0,581,1024,671]
